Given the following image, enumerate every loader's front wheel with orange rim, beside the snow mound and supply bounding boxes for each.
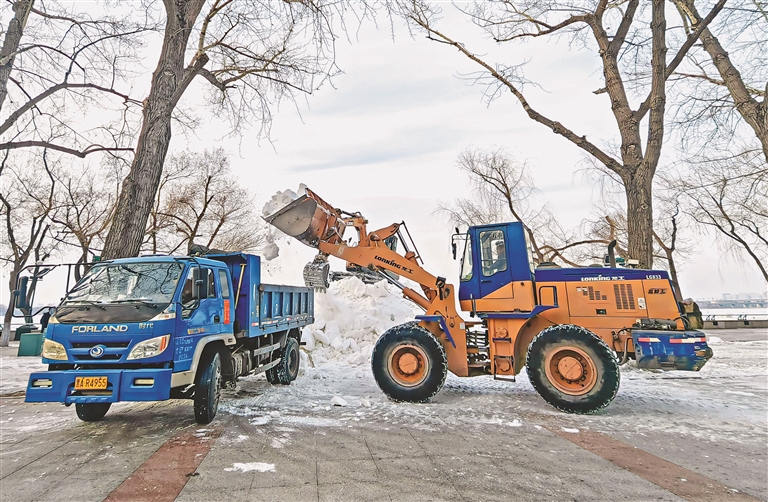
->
[371,323,448,403]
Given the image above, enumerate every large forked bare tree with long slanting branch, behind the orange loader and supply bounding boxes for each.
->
[405,0,725,268]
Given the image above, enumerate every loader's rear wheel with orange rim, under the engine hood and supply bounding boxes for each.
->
[525,325,620,414]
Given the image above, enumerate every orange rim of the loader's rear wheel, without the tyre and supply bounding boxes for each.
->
[544,346,597,396]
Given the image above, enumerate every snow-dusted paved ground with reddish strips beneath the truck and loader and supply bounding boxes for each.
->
[0,330,768,502]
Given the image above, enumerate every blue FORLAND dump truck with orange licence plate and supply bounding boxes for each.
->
[15,253,314,424]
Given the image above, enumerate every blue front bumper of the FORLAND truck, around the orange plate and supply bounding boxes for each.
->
[24,368,173,403]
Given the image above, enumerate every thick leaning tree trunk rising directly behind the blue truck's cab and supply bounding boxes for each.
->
[103,0,208,259]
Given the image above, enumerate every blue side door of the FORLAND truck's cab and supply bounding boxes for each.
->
[174,266,224,371]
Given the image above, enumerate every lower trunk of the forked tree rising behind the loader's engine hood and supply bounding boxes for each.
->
[624,176,653,269]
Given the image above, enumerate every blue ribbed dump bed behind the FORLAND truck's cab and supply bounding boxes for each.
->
[208,253,315,338]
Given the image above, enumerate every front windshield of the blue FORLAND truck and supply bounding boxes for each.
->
[62,262,184,305]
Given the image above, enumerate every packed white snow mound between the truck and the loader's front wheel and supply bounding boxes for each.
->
[301,277,421,366]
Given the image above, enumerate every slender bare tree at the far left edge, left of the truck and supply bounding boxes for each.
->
[0,150,56,347]
